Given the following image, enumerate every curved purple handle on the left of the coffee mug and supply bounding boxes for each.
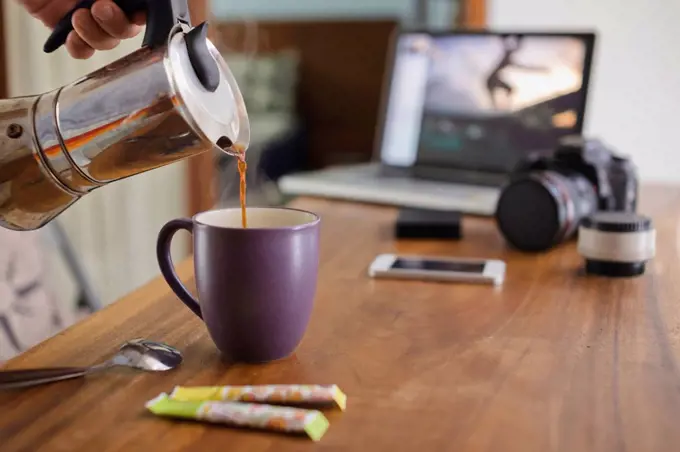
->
[156,218,203,319]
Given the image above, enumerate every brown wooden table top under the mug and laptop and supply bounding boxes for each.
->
[0,188,680,452]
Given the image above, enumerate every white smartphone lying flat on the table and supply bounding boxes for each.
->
[368,254,505,285]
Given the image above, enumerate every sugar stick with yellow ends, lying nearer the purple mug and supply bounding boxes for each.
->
[170,385,347,411]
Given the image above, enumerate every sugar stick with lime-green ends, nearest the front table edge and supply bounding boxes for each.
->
[146,394,328,441]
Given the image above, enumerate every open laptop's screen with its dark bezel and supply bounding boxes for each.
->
[379,33,594,172]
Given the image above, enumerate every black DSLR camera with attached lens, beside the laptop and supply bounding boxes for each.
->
[496,137,638,251]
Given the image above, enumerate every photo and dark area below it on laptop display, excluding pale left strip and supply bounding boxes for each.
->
[417,34,592,172]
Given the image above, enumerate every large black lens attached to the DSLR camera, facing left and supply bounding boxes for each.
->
[496,171,597,251]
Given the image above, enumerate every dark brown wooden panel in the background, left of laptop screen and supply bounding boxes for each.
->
[215,18,398,168]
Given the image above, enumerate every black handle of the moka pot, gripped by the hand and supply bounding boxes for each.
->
[43,0,191,53]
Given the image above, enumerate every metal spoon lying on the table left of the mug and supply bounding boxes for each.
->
[0,339,182,390]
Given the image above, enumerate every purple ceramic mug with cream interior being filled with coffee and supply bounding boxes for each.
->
[157,208,319,363]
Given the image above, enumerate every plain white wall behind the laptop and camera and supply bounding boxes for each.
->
[488,0,680,182]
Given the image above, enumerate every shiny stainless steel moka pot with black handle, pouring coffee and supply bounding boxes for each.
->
[0,0,250,230]
